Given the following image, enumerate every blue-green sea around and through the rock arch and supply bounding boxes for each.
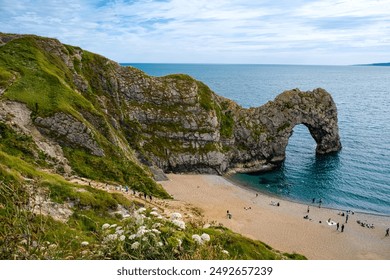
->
[123,63,390,216]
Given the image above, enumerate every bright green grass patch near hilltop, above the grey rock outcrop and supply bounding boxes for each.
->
[0,36,93,116]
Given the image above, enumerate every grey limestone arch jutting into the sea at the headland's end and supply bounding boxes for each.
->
[231,89,341,172]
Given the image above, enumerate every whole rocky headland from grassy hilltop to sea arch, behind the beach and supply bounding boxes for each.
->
[0,34,341,177]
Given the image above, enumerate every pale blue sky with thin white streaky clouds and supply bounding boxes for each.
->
[0,0,390,65]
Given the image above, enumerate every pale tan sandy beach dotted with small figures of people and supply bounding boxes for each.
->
[160,174,390,260]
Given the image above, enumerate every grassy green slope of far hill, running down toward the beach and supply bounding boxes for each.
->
[0,33,168,197]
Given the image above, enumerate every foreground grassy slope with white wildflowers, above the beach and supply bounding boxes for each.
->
[0,133,304,259]
